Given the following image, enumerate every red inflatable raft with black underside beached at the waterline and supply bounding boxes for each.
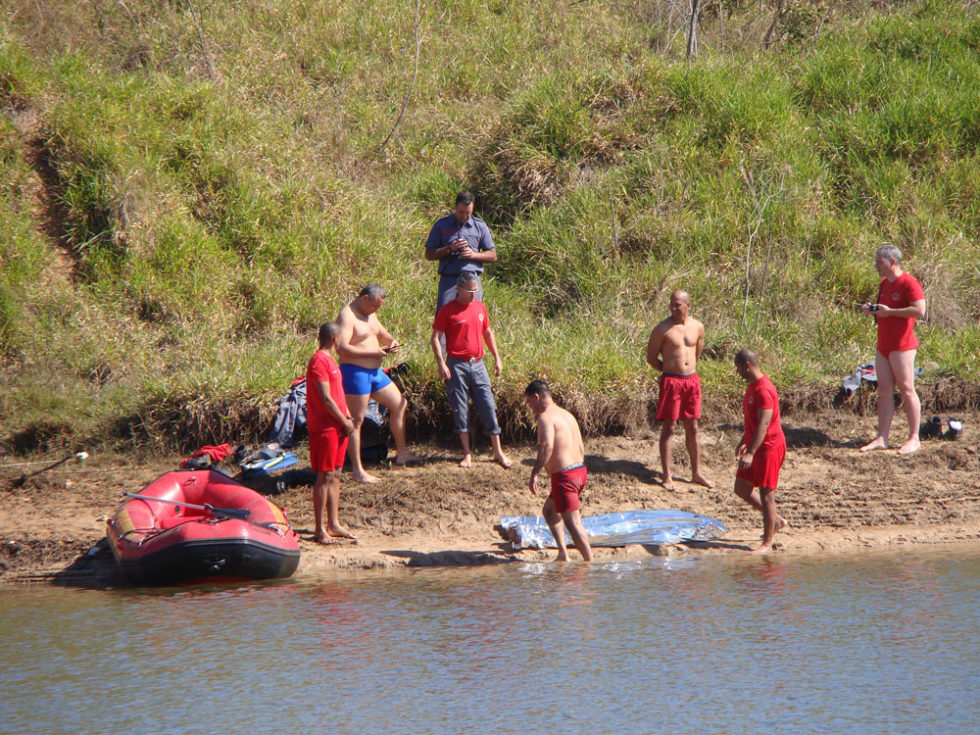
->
[106,470,299,585]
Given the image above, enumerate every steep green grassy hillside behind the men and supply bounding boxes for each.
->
[0,0,980,448]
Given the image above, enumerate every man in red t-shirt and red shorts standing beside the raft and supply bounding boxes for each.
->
[306,322,357,544]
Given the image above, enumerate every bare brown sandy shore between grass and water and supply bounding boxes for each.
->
[0,412,980,587]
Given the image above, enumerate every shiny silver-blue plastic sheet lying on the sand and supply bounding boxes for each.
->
[500,510,728,549]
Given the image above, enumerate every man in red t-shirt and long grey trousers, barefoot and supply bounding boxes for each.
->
[430,272,510,469]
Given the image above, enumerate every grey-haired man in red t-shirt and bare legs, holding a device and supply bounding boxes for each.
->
[861,243,926,454]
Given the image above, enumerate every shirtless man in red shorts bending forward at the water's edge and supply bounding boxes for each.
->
[524,380,592,561]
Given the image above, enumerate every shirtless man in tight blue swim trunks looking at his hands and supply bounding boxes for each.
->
[336,283,419,482]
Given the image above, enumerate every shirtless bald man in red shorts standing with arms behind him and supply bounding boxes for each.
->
[647,290,714,490]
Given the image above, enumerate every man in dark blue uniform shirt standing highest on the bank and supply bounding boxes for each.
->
[425,191,497,313]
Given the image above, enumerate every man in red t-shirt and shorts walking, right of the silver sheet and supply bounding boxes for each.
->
[735,350,786,553]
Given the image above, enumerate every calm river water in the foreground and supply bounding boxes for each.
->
[0,549,980,734]
